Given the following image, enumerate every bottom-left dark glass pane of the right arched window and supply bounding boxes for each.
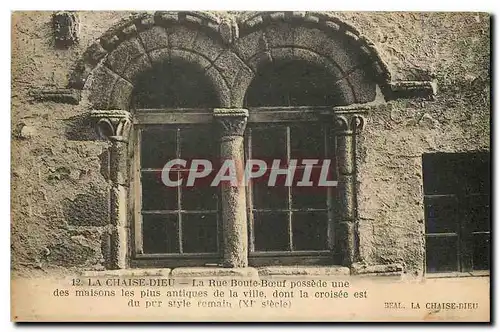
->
[253,212,290,251]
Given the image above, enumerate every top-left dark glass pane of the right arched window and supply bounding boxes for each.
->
[252,127,287,160]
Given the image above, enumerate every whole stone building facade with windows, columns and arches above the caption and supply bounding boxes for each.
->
[11,12,490,276]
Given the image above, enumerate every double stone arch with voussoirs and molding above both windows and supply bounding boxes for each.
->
[61,11,435,109]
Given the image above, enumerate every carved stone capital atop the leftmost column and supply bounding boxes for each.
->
[90,110,132,142]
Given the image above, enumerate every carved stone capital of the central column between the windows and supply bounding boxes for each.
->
[213,108,248,137]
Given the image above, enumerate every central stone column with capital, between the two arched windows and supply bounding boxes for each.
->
[214,109,248,267]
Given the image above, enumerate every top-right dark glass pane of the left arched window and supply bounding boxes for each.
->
[181,126,217,162]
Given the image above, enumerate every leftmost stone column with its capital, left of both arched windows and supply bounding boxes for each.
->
[90,111,131,270]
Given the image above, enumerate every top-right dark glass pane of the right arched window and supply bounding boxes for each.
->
[290,124,325,159]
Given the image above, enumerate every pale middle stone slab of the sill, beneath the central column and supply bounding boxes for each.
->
[171,267,259,278]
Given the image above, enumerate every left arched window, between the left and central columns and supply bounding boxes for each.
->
[131,60,221,266]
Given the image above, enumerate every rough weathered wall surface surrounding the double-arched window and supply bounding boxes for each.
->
[11,12,490,274]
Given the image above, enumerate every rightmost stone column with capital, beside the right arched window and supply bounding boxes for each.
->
[335,110,365,266]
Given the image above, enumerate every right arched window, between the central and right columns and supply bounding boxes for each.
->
[245,60,342,265]
